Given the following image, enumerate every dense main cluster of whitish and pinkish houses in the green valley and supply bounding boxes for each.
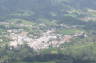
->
[7,29,87,50]
